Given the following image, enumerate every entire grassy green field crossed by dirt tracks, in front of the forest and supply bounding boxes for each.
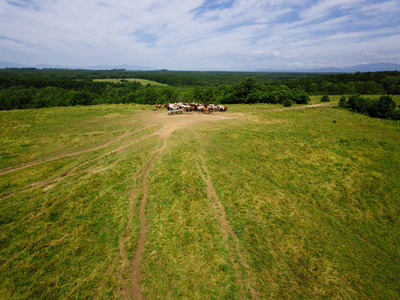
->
[0,102,400,299]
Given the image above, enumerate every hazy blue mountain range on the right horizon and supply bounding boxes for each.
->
[260,63,400,73]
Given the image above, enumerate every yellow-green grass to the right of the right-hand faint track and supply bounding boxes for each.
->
[191,105,400,298]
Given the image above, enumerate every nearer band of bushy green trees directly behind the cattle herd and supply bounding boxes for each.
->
[0,78,309,110]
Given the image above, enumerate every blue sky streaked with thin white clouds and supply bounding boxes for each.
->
[0,0,400,71]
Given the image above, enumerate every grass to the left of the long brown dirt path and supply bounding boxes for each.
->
[0,106,157,299]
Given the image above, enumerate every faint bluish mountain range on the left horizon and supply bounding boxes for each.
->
[0,61,156,71]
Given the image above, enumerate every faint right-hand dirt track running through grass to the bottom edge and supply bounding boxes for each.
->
[197,157,258,299]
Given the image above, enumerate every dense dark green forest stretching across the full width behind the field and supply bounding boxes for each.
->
[0,68,400,119]
